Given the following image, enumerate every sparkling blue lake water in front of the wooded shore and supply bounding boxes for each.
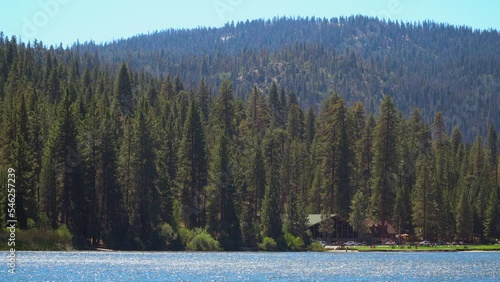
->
[0,252,500,281]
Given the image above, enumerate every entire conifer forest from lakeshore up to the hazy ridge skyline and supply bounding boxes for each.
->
[0,17,500,250]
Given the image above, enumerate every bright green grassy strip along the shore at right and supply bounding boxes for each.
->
[349,245,500,252]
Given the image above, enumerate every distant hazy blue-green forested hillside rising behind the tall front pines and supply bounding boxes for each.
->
[79,16,500,142]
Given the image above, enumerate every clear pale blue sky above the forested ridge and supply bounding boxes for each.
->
[0,0,500,46]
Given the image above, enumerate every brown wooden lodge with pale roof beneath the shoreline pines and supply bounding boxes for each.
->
[308,214,396,242]
